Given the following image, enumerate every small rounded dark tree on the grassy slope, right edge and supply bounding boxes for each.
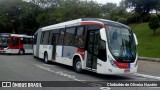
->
[149,16,160,35]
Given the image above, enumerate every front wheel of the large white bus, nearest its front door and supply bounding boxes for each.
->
[73,58,82,73]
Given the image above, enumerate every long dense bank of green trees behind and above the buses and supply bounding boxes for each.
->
[0,0,156,34]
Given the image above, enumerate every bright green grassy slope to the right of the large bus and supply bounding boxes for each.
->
[130,23,160,58]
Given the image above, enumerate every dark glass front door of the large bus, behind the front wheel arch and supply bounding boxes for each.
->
[86,30,99,70]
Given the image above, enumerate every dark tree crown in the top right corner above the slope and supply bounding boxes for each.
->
[125,0,159,20]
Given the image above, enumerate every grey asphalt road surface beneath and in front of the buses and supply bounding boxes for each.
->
[0,55,160,90]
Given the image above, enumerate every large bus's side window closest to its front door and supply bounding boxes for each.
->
[75,27,85,46]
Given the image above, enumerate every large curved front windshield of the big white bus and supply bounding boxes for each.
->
[107,26,136,62]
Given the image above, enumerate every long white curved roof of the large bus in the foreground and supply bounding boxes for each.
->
[42,18,130,31]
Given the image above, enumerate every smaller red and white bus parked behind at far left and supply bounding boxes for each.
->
[0,33,33,55]
